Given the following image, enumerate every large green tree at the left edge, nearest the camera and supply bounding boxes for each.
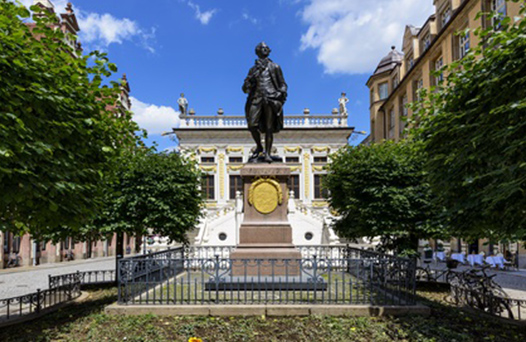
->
[0,0,137,237]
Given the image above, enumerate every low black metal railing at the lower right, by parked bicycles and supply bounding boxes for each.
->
[449,285,526,321]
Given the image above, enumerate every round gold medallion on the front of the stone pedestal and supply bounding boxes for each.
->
[248,178,283,215]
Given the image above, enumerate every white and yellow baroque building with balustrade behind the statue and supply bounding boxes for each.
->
[172,109,354,246]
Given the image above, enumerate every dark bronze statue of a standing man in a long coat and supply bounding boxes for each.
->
[243,43,287,163]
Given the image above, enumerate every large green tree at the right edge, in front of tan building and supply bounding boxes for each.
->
[413,1,526,241]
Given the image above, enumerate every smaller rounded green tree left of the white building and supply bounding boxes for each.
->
[94,149,203,243]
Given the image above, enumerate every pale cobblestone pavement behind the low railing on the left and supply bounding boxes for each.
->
[0,257,115,299]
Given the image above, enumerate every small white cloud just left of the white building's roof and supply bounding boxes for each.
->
[130,97,180,135]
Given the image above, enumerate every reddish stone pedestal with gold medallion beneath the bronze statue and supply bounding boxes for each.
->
[231,163,301,277]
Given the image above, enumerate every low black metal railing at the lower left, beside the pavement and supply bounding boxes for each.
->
[0,279,81,324]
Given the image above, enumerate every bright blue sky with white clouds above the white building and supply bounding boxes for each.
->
[22,0,433,149]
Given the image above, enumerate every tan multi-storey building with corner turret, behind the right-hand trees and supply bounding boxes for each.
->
[366,0,526,267]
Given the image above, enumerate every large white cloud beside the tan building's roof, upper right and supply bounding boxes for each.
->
[301,0,433,74]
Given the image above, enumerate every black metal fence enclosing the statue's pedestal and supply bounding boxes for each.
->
[118,255,415,305]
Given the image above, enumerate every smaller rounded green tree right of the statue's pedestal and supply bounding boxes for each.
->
[325,142,444,254]
